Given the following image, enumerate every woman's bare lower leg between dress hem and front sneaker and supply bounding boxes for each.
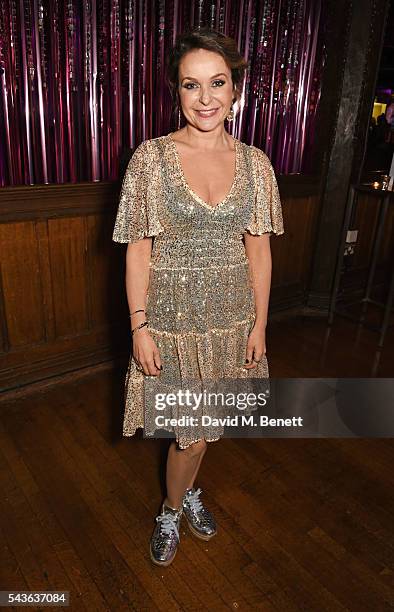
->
[164,440,207,508]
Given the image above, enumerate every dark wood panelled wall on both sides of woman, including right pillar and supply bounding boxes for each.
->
[0,0,387,389]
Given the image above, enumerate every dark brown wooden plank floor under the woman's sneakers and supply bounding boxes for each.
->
[0,311,394,612]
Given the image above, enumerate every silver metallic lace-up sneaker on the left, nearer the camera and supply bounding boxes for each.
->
[150,503,183,565]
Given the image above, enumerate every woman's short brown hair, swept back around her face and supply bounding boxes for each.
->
[166,26,248,113]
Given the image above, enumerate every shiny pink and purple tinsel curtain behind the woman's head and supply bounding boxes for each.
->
[0,0,325,186]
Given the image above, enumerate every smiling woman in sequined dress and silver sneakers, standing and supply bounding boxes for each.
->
[113,28,284,565]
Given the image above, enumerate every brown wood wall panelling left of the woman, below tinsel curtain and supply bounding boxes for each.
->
[0,183,124,388]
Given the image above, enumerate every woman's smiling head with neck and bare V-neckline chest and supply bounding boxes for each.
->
[168,40,246,206]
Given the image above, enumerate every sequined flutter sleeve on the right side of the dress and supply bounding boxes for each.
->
[245,147,285,236]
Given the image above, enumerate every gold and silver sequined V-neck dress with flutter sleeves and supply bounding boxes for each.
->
[112,134,284,448]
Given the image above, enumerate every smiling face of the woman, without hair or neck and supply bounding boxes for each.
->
[178,49,235,131]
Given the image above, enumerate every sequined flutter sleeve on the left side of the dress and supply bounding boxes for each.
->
[112,140,164,242]
